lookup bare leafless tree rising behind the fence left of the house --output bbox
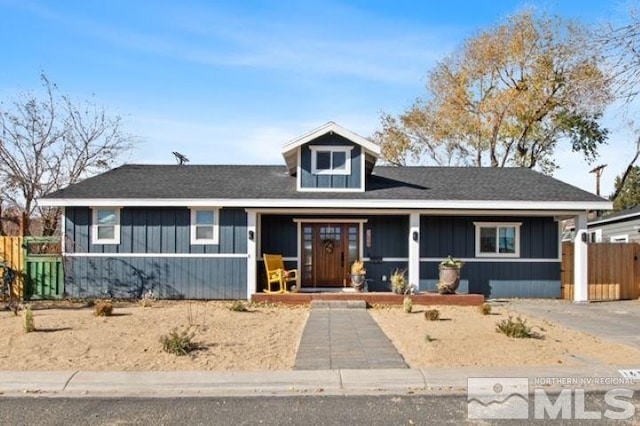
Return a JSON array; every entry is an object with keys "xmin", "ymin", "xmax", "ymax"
[{"xmin": 0, "ymin": 74, "xmax": 134, "ymax": 235}]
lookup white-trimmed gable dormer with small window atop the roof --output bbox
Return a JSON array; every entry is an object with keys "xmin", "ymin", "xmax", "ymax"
[{"xmin": 282, "ymin": 121, "xmax": 380, "ymax": 192}]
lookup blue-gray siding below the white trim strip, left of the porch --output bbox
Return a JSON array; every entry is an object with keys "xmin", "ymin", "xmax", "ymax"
[{"xmin": 65, "ymin": 257, "xmax": 247, "ymax": 299}]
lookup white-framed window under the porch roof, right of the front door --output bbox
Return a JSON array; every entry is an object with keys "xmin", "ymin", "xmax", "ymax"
[{"xmin": 474, "ymin": 222, "xmax": 522, "ymax": 257}]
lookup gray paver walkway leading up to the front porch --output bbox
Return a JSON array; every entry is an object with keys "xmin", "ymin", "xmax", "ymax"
[{"xmin": 293, "ymin": 301, "xmax": 408, "ymax": 370}]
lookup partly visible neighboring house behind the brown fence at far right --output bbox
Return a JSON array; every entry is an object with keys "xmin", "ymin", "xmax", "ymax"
[{"xmin": 587, "ymin": 206, "xmax": 640, "ymax": 243}]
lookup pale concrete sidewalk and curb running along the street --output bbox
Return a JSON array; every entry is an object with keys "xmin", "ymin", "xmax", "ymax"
[{"xmin": 0, "ymin": 362, "xmax": 640, "ymax": 397}]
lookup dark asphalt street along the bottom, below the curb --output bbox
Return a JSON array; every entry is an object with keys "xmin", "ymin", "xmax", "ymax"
[{"xmin": 0, "ymin": 392, "xmax": 640, "ymax": 426}]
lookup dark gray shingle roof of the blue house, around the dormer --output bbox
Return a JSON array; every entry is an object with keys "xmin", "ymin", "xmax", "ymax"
[{"xmin": 44, "ymin": 165, "xmax": 605, "ymax": 203}]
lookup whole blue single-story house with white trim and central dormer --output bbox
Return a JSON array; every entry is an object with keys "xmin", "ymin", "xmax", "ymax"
[{"xmin": 39, "ymin": 122, "xmax": 611, "ymax": 299}]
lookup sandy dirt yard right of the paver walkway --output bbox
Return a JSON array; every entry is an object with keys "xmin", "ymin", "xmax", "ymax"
[{"xmin": 371, "ymin": 306, "xmax": 640, "ymax": 367}]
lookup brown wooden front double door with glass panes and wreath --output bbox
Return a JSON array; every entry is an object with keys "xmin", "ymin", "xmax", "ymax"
[{"xmin": 301, "ymin": 223, "xmax": 360, "ymax": 287}]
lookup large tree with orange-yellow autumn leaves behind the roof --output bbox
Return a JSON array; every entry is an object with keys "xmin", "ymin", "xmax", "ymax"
[{"xmin": 374, "ymin": 12, "xmax": 612, "ymax": 173}]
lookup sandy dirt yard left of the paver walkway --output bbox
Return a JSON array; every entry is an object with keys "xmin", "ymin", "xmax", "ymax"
[{"xmin": 0, "ymin": 301, "xmax": 308, "ymax": 371}]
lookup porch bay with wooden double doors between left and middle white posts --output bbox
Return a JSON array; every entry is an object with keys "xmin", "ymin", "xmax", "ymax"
[{"xmin": 249, "ymin": 209, "xmax": 420, "ymax": 301}]
